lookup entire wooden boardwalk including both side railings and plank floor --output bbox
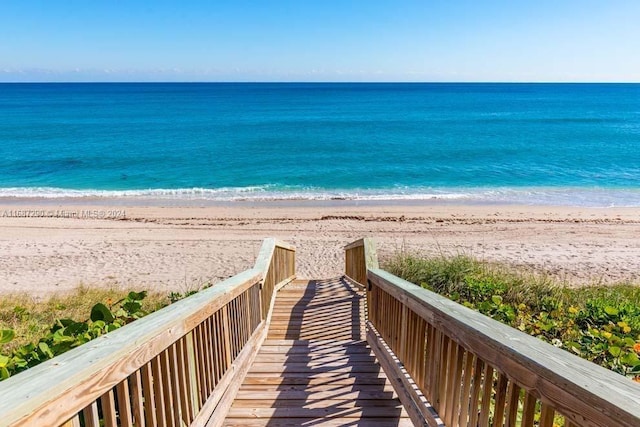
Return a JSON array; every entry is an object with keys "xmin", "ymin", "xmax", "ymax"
[{"xmin": 0, "ymin": 238, "xmax": 640, "ymax": 427}]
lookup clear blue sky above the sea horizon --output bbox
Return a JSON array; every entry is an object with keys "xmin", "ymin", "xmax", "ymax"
[{"xmin": 0, "ymin": 0, "xmax": 640, "ymax": 82}]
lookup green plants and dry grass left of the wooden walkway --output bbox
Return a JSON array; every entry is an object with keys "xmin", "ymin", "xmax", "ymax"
[{"xmin": 0, "ymin": 287, "xmax": 195, "ymax": 381}]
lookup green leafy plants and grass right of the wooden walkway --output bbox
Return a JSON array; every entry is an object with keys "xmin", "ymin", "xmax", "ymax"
[{"xmin": 384, "ymin": 254, "xmax": 640, "ymax": 382}]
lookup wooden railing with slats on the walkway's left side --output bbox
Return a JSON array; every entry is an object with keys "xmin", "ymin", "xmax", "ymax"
[{"xmin": 0, "ymin": 239, "xmax": 295, "ymax": 427}]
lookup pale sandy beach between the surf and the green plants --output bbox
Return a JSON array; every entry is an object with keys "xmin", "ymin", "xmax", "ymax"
[{"xmin": 0, "ymin": 200, "xmax": 640, "ymax": 296}]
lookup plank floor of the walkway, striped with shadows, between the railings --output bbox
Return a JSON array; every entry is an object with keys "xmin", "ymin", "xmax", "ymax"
[{"xmin": 225, "ymin": 279, "xmax": 413, "ymax": 426}]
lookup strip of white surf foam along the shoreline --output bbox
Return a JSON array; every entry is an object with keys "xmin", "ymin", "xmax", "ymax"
[{"xmin": 0, "ymin": 185, "xmax": 640, "ymax": 207}]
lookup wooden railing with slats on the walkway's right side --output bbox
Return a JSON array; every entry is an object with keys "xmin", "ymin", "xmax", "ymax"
[{"xmin": 346, "ymin": 237, "xmax": 640, "ymax": 427}]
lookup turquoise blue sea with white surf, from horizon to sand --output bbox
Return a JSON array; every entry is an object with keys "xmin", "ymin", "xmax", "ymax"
[{"xmin": 0, "ymin": 83, "xmax": 640, "ymax": 206}]
